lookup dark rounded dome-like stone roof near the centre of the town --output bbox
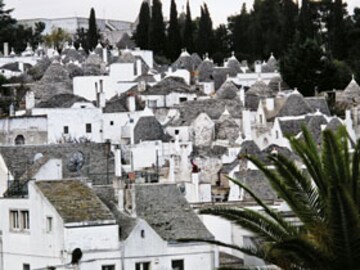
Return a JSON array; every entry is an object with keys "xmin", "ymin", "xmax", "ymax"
[{"xmin": 134, "ymin": 116, "xmax": 170, "ymax": 143}]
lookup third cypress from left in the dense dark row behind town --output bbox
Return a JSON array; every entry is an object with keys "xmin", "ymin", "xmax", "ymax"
[{"xmin": 166, "ymin": 0, "xmax": 181, "ymax": 61}]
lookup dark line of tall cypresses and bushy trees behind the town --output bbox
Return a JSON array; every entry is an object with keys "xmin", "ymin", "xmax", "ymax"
[{"xmin": 133, "ymin": 0, "xmax": 360, "ymax": 95}]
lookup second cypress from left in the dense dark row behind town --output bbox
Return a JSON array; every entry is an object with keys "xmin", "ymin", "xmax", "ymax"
[{"xmin": 149, "ymin": 0, "xmax": 166, "ymax": 55}]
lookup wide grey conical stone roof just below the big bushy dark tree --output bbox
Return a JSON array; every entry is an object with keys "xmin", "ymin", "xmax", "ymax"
[{"xmin": 277, "ymin": 92, "xmax": 314, "ymax": 117}]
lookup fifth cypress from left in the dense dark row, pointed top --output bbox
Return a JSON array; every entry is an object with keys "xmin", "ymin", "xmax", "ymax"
[{"xmin": 196, "ymin": 3, "xmax": 214, "ymax": 55}]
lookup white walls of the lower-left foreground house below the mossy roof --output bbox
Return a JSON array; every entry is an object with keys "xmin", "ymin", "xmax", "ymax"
[{"xmin": 0, "ymin": 182, "xmax": 120, "ymax": 270}]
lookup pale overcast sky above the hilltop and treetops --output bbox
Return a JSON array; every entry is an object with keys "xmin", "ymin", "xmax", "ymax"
[{"xmin": 4, "ymin": 0, "xmax": 360, "ymax": 25}]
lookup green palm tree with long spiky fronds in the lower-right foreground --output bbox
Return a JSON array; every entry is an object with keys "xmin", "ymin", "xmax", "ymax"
[{"xmin": 201, "ymin": 128, "xmax": 360, "ymax": 270}]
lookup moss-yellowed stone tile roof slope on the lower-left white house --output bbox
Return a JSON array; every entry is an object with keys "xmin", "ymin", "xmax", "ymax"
[{"xmin": 35, "ymin": 180, "xmax": 114, "ymax": 225}]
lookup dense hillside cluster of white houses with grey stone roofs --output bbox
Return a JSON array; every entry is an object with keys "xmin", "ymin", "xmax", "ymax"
[{"xmin": 0, "ymin": 39, "xmax": 360, "ymax": 270}]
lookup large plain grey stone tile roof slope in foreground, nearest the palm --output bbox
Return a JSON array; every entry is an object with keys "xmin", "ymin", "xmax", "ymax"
[{"xmin": 134, "ymin": 184, "xmax": 213, "ymax": 241}]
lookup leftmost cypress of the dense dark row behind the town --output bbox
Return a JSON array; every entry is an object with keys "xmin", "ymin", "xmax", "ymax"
[{"xmin": 134, "ymin": 1, "xmax": 150, "ymax": 50}]
